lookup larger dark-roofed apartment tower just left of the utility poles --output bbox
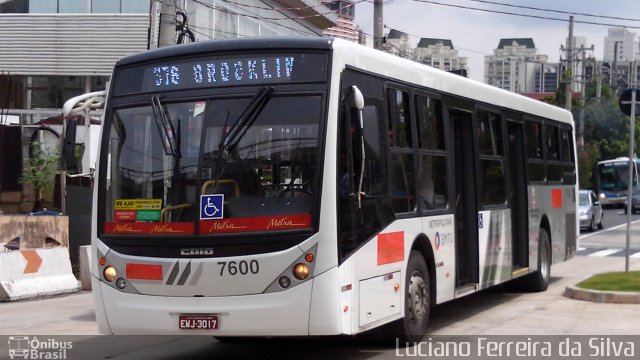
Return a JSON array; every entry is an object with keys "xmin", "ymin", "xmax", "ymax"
[{"xmin": 484, "ymin": 38, "xmax": 551, "ymax": 93}]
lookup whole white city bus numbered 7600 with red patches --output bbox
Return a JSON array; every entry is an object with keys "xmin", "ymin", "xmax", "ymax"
[{"xmin": 92, "ymin": 38, "xmax": 578, "ymax": 341}]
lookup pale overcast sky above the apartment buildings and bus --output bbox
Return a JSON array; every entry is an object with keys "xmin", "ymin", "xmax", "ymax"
[{"xmin": 355, "ymin": 0, "xmax": 640, "ymax": 81}]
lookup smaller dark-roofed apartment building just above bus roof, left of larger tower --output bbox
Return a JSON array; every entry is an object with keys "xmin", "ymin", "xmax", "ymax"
[{"xmin": 413, "ymin": 38, "xmax": 469, "ymax": 75}]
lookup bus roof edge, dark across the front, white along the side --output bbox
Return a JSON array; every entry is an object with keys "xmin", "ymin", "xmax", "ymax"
[{"xmin": 116, "ymin": 37, "xmax": 573, "ymax": 126}]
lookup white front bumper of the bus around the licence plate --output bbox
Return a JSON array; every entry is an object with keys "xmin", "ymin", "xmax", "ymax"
[{"xmin": 94, "ymin": 278, "xmax": 313, "ymax": 336}]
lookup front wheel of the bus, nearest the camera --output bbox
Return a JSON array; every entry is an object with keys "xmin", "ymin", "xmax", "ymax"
[{"xmin": 385, "ymin": 250, "xmax": 432, "ymax": 345}]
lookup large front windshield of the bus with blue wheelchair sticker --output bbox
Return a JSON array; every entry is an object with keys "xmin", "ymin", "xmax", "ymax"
[{"xmin": 102, "ymin": 91, "xmax": 323, "ymax": 235}]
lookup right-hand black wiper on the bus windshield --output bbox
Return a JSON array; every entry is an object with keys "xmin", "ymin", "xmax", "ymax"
[{"xmin": 218, "ymin": 86, "xmax": 273, "ymax": 153}]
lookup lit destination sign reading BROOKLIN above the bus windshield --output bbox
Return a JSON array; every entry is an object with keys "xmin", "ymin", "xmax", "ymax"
[{"xmin": 116, "ymin": 53, "xmax": 327, "ymax": 95}]
